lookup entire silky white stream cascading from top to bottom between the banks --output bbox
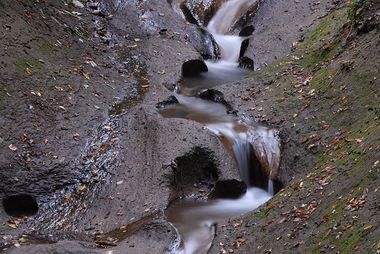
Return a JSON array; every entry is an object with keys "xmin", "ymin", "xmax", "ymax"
[{"xmin": 160, "ymin": 0, "xmax": 280, "ymax": 254}]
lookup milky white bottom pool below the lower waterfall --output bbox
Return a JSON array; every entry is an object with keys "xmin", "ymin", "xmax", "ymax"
[{"xmin": 167, "ymin": 188, "xmax": 272, "ymax": 254}]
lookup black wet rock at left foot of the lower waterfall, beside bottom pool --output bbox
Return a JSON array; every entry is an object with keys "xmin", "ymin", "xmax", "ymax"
[{"xmin": 209, "ymin": 179, "xmax": 247, "ymax": 199}]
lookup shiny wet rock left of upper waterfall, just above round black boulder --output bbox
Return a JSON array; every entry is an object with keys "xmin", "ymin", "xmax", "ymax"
[{"xmin": 187, "ymin": 25, "xmax": 220, "ymax": 59}]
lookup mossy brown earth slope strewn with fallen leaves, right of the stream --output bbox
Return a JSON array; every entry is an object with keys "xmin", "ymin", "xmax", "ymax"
[{"xmin": 211, "ymin": 1, "xmax": 380, "ymax": 253}]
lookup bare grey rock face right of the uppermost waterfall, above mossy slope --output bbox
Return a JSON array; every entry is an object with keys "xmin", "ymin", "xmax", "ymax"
[{"xmin": 245, "ymin": 0, "xmax": 333, "ymax": 67}]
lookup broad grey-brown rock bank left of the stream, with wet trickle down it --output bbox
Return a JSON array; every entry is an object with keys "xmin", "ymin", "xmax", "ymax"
[{"xmin": 0, "ymin": 1, "xmax": 239, "ymax": 253}]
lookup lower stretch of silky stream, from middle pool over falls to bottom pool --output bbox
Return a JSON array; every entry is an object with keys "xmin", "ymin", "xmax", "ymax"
[{"xmin": 161, "ymin": 94, "xmax": 280, "ymax": 254}]
